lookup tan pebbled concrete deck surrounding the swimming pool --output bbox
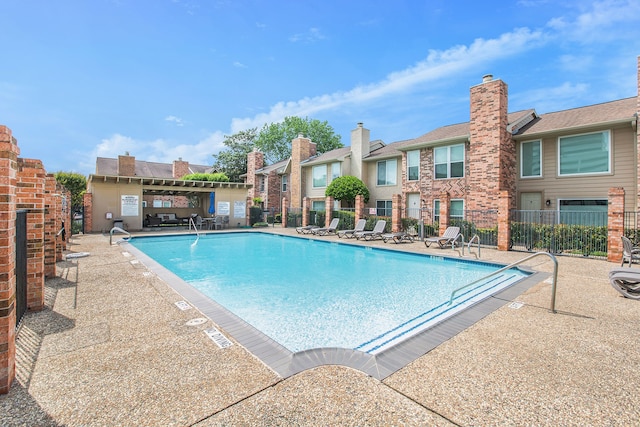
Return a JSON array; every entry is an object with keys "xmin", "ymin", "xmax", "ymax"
[{"xmin": 0, "ymin": 228, "xmax": 640, "ymax": 426}]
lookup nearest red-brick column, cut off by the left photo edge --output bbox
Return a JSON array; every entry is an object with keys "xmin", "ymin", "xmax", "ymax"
[{"xmin": 0, "ymin": 126, "xmax": 20, "ymax": 394}]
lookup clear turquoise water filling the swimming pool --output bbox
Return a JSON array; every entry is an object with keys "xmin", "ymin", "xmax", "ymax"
[{"xmin": 130, "ymin": 233, "xmax": 527, "ymax": 354}]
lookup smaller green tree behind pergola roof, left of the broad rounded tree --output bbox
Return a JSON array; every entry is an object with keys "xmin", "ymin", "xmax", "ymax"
[{"xmin": 213, "ymin": 128, "xmax": 257, "ymax": 182}]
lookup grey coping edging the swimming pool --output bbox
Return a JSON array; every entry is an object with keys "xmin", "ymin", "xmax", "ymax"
[{"xmin": 120, "ymin": 241, "xmax": 550, "ymax": 380}]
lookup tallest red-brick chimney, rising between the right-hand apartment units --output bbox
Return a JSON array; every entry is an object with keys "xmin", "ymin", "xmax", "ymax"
[{"xmin": 465, "ymin": 74, "xmax": 516, "ymax": 210}]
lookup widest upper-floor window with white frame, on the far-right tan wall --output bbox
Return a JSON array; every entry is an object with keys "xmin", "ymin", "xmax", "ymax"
[{"xmin": 558, "ymin": 131, "xmax": 611, "ymax": 176}]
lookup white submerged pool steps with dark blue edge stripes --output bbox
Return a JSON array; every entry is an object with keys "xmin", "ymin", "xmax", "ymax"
[{"xmin": 354, "ymin": 271, "xmax": 522, "ymax": 354}]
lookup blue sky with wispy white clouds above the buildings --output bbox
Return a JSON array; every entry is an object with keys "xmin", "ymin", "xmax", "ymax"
[{"xmin": 0, "ymin": 0, "xmax": 640, "ymax": 175}]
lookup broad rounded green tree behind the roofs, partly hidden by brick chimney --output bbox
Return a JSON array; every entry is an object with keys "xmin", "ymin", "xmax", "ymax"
[{"xmin": 255, "ymin": 116, "xmax": 344, "ymax": 164}]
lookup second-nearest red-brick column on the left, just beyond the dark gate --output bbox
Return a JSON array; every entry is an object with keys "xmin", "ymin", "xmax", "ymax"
[{"xmin": 16, "ymin": 159, "xmax": 46, "ymax": 310}]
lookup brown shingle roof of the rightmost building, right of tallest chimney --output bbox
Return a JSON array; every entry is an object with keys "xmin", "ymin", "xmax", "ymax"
[{"xmin": 517, "ymin": 97, "xmax": 638, "ymax": 135}]
